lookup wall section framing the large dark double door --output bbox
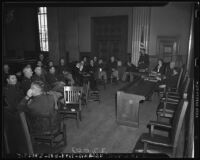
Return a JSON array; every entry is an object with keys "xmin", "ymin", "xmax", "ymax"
[{"xmin": 79, "ymin": 7, "xmax": 132, "ymax": 53}]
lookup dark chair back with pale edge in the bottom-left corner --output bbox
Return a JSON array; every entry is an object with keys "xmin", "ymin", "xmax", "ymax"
[{"xmin": 4, "ymin": 109, "xmax": 33, "ymax": 154}]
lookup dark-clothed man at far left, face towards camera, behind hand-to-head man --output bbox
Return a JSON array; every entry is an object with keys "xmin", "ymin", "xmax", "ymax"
[{"xmin": 4, "ymin": 73, "xmax": 24, "ymax": 112}]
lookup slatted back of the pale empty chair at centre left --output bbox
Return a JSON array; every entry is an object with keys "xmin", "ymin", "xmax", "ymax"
[{"xmin": 64, "ymin": 86, "xmax": 83, "ymax": 104}]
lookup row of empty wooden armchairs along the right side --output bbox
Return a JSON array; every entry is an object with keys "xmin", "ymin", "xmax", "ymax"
[{"xmin": 133, "ymin": 66, "xmax": 192, "ymax": 157}]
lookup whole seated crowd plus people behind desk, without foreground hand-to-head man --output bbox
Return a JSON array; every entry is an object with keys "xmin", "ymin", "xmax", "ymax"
[{"xmin": 3, "ymin": 50, "xmax": 178, "ymax": 115}]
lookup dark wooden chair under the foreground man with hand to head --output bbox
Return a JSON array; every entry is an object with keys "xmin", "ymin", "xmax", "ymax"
[{"xmin": 26, "ymin": 111, "xmax": 67, "ymax": 151}]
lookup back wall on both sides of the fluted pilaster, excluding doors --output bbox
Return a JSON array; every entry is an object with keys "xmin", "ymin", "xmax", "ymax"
[{"xmin": 48, "ymin": 2, "xmax": 191, "ymax": 62}]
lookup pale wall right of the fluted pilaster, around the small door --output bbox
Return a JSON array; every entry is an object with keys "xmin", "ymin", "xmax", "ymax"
[{"xmin": 149, "ymin": 2, "xmax": 191, "ymax": 63}]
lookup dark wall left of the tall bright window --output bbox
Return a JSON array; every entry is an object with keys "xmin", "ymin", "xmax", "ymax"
[{"xmin": 4, "ymin": 7, "xmax": 39, "ymax": 58}]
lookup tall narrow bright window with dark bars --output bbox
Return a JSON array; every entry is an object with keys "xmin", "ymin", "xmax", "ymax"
[{"xmin": 38, "ymin": 7, "xmax": 49, "ymax": 51}]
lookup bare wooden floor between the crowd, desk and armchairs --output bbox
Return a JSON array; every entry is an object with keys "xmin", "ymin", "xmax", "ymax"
[{"xmin": 34, "ymin": 82, "xmax": 166, "ymax": 153}]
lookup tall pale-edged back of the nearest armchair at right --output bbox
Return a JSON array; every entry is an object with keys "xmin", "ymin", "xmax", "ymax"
[{"xmin": 171, "ymin": 99, "xmax": 188, "ymax": 151}]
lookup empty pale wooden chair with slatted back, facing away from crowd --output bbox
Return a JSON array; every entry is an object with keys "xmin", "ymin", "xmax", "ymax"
[{"xmin": 59, "ymin": 86, "xmax": 83, "ymax": 127}]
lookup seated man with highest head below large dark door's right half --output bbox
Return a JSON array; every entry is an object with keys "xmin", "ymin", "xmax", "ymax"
[{"xmin": 108, "ymin": 56, "xmax": 119, "ymax": 81}]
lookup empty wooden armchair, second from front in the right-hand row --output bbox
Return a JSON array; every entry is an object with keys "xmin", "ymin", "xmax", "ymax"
[{"xmin": 156, "ymin": 78, "xmax": 190, "ymax": 121}]
